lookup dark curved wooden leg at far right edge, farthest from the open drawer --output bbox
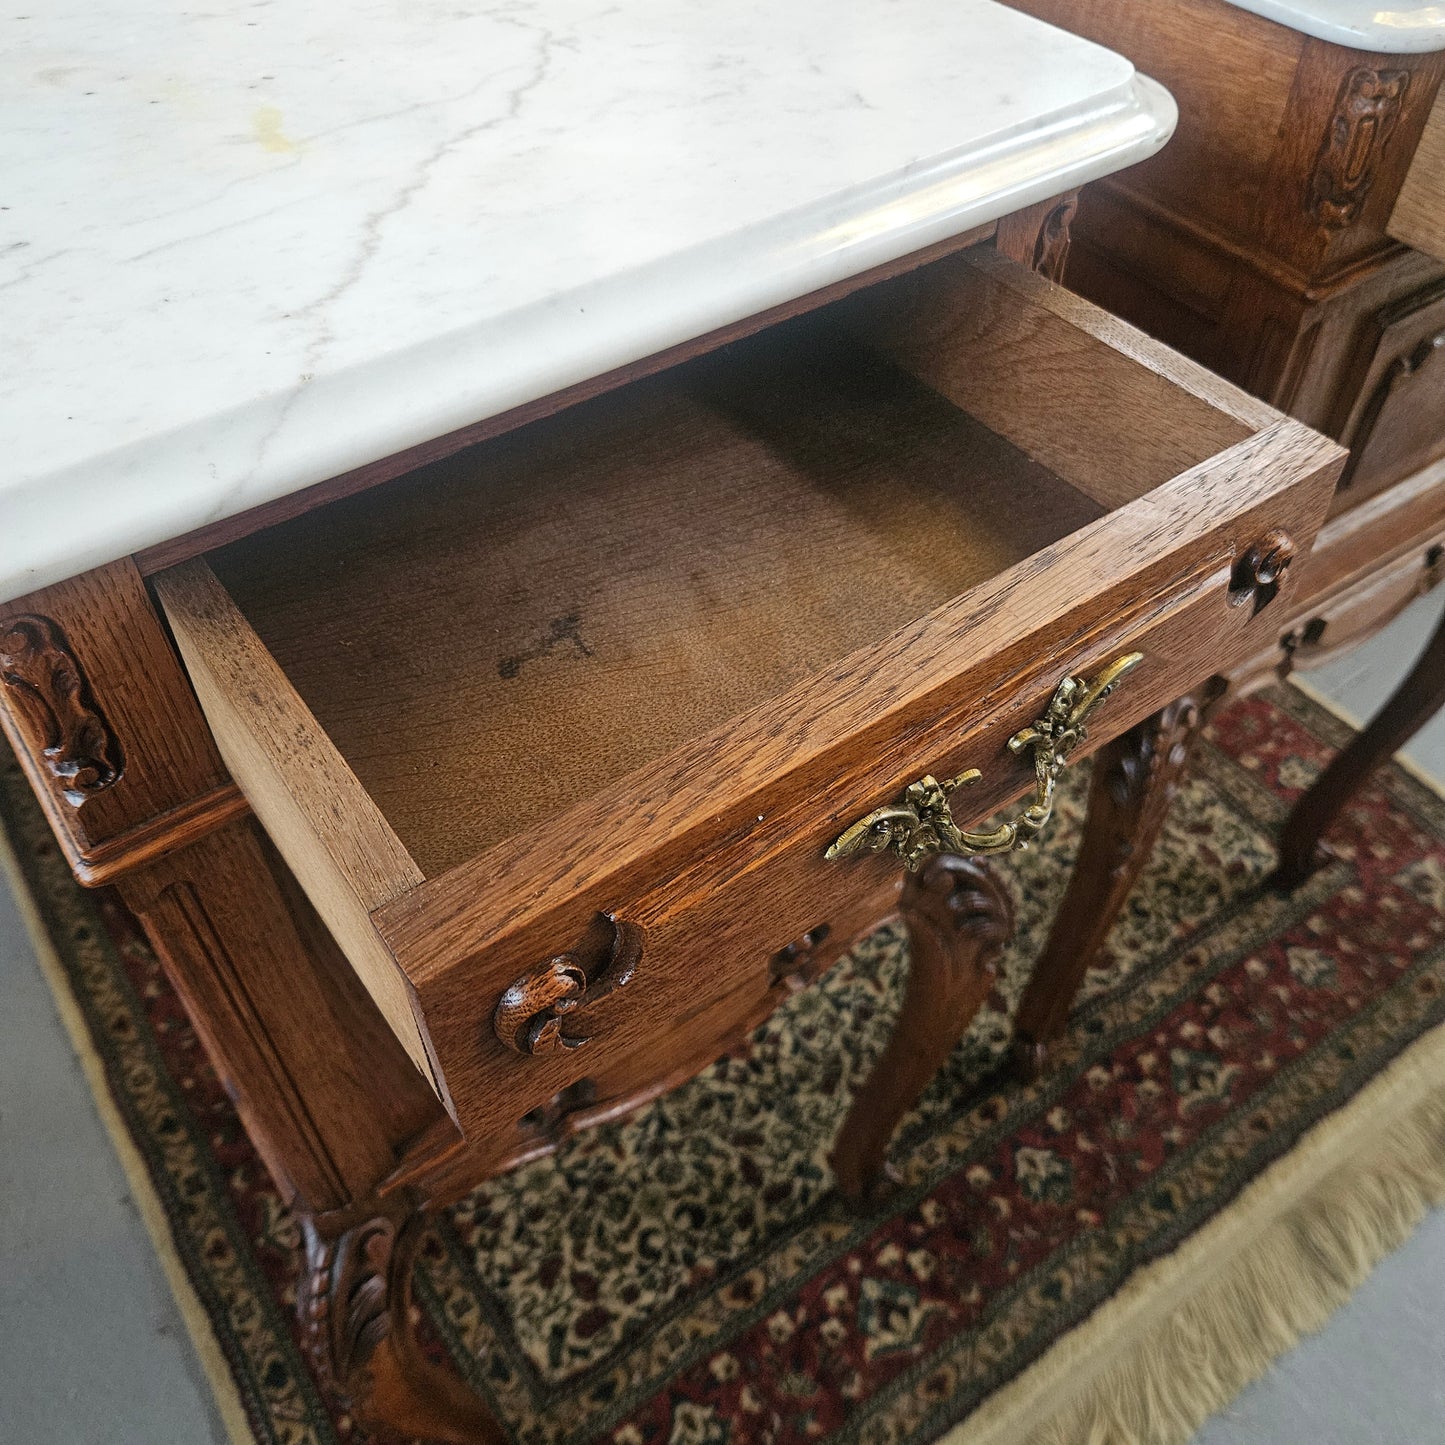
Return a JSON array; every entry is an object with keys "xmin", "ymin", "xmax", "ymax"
[{"xmin": 1270, "ymin": 601, "xmax": 1445, "ymax": 893}]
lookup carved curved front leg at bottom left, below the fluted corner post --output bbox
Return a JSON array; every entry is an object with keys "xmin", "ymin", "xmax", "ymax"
[{"xmin": 296, "ymin": 1201, "xmax": 506, "ymax": 1445}]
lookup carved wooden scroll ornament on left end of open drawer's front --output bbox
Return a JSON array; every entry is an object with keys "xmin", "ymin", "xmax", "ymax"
[{"xmin": 491, "ymin": 913, "xmax": 643, "ymax": 1055}]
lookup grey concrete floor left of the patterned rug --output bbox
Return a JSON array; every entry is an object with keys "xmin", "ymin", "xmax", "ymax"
[{"xmin": 0, "ymin": 849, "xmax": 225, "ymax": 1445}]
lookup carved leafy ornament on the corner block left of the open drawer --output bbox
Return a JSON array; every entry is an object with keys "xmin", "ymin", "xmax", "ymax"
[{"xmin": 0, "ymin": 613, "xmax": 126, "ymax": 806}]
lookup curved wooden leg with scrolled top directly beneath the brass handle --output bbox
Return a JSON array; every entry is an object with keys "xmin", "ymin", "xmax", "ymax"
[{"xmin": 831, "ymin": 854, "xmax": 1013, "ymax": 1202}]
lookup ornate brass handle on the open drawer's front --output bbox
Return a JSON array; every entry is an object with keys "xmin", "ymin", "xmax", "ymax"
[{"xmin": 824, "ymin": 652, "xmax": 1143, "ymax": 873}]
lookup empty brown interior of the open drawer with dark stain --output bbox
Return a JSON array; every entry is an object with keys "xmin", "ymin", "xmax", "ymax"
[{"xmin": 200, "ymin": 249, "xmax": 1251, "ymax": 877}]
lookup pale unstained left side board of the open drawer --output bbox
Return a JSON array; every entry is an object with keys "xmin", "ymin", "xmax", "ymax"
[{"xmin": 156, "ymin": 559, "xmax": 441, "ymax": 1092}]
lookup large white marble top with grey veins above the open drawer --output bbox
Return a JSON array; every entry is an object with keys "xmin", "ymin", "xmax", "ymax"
[{"xmin": 0, "ymin": 0, "xmax": 1175, "ymax": 598}]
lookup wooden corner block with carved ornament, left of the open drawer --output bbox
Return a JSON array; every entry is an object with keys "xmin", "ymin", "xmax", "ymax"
[{"xmin": 0, "ymin": 561, "xmax": 246, "ymax": 884}]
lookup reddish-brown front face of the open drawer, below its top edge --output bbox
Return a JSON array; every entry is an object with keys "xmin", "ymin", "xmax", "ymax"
[{"xmin": 378, "ymin": 497, "xmax": 1321, "ymax": 1147}]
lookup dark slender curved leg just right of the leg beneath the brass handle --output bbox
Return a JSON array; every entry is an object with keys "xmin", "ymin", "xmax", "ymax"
[{"xmin": 1012, "ymin": 696, "xmax": 1205, "ymax": 1081}]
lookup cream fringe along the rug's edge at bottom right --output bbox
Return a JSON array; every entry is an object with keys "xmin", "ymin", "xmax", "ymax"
[{"xmin": 945, "ymin": 1027, "xmax": 1445, "ymax": 1445}]
